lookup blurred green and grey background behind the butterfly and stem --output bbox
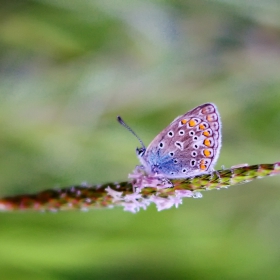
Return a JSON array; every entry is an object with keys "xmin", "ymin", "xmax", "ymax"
[{"xmin": 0, "ymin": 0, "xmax": 280, "ymax": 280}]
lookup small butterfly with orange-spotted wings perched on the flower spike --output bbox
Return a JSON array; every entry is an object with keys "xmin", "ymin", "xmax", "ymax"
[{"xmin": 117, "ymin": 103, "xmax": 222, "ymax": 179}]
